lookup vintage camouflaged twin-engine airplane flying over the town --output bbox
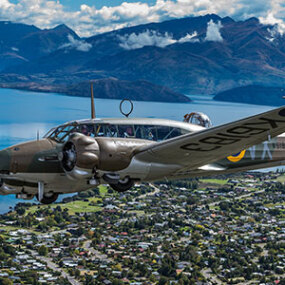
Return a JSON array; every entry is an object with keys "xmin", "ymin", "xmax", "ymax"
[{"xmin": 0, "ymin": 89, "xmax": 285, "ymax": 204}]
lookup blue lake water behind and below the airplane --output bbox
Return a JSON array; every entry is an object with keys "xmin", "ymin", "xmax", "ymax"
[{"xmin": 0, "ymin": 89, "xmax": 274, "ymax": 214}]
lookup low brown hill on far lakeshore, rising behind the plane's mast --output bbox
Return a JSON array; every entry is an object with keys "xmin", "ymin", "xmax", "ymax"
[{"xmin": 0, "ymin": 78, "xmax": 191, "ymax": 103}]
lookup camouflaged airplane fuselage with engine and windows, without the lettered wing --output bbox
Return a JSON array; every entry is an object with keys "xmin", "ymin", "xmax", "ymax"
[{"xmin": 0, "ymin": 116, "xmax": 285, "ymax": 201}]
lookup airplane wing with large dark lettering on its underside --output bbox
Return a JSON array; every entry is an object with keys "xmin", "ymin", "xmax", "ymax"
[{"xmin": 135, "ymin": 106, "xmax": 285, "ymax": 171}]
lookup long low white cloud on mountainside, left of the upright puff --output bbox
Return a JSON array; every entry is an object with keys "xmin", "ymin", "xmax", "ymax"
[{"xmin": 118, "ymin": 30, "xmax": 199, "ymax": 50}]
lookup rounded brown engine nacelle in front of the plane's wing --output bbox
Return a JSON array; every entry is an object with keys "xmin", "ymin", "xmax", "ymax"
[{"xmin": 59, "ymin": 133, "xmax": 133, "ymax": 179}]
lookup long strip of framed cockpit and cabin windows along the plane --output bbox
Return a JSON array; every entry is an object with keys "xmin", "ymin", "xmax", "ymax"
[{"xmin": 45, "ymin": 121, "xmax": 189, "ymax": 143}]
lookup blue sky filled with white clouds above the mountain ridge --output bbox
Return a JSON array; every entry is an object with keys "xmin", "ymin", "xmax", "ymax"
[{"xmin": 0, "ymin": 0, "xmax": 285, "ymax": 37}]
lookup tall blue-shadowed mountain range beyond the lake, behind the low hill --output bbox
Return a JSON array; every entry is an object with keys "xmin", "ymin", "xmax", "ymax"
[{"xmin": 0, "ymin": 14, "xmax": 285, "ymax": 101}]
